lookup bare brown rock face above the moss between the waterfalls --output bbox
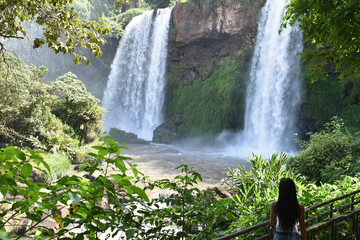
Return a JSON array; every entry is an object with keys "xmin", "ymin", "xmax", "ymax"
[{"xmin": 167, "ymin": 0, "xmax": 265, "ymax": 83}]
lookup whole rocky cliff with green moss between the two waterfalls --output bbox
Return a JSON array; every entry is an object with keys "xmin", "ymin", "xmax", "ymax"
[{"xmin": 154, "ymin": 0, "xmax": 266, "ymax": 142}]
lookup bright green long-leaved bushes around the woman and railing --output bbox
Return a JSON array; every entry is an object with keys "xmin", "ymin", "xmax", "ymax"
[{"xmin": 222, "ymin": 154, "xmax": 360, "ymax": 240}]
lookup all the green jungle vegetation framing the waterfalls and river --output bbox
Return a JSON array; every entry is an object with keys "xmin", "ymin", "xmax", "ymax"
[{"xmin": 0, "ymin": 0, "xmax": 360, "ymax": 240}]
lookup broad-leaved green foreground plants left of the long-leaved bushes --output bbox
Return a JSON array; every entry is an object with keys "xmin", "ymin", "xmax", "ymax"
[{"xmin": 0, "ymin": 139, "xmax": 236, "ymax": 239}]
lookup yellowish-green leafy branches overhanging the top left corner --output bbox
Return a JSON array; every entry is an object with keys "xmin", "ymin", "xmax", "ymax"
[{"xmin": 0, "ymin": 0, "xmax": 127, "ymax": 64}]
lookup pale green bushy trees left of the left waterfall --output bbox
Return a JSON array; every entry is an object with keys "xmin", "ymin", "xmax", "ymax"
[{"xmin": 0, "ymin": 54, "xmax": 104, "ymax": 158}]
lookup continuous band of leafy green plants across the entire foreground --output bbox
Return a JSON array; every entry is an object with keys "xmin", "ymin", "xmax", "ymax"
[{"xmin": 0, "ymin": 139, "xmax": 360, "ymax": 240}]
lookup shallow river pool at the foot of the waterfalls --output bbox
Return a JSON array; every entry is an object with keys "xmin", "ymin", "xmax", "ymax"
[{"xmin": 121, "ymin": 143, "xmax": 250, "ymax": 198}]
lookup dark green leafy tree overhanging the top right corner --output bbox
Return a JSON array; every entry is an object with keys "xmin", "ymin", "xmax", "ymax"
[{"xmin": 282, "ymin": 0, "xmax": 360, "ymax": 79}]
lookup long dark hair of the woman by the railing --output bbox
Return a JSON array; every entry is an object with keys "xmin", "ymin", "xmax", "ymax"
[{"xmin": 276, "ymin": 178, "xmax": 300, "ymax": 232}]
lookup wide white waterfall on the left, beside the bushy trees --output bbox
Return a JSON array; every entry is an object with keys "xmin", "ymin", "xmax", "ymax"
[{"xmin": 103, "ymin": 8, "xmax": 172, "ymax": 140}]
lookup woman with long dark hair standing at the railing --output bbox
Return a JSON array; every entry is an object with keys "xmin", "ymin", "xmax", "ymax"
[{"xmin": 270, "ymin": 178, "xmax": 307, "ymax": 240}]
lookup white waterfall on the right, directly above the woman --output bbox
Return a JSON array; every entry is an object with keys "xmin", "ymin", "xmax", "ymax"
[{"xmin": 226, "ymin": 0, "xmax": 303, "ymax": 157}]
